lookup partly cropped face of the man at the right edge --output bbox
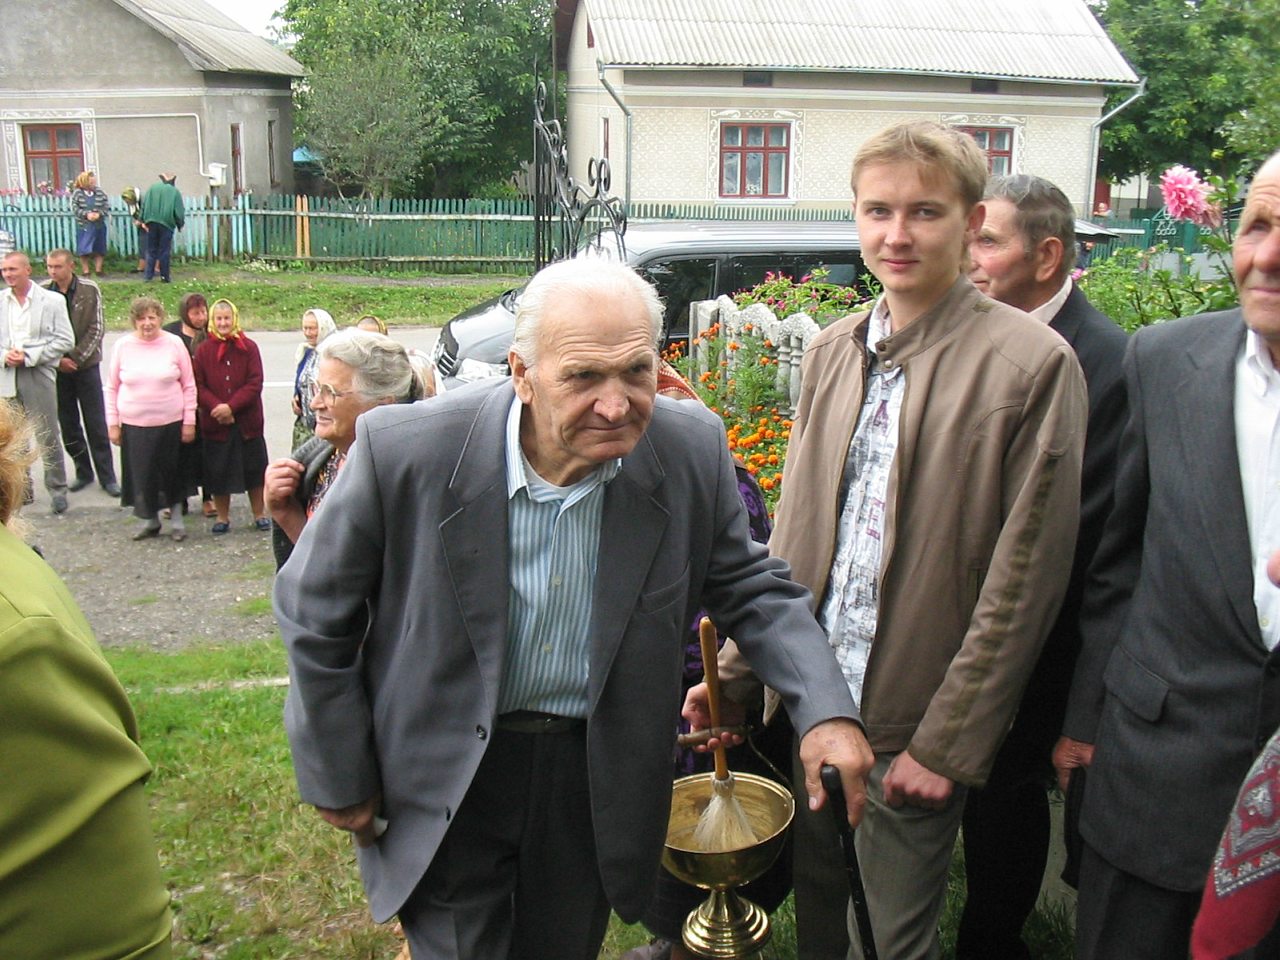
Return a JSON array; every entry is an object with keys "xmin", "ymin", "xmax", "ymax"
[{"xmin": 1233, "ymin": 157, "xmax": 1280, "ymax": 355}]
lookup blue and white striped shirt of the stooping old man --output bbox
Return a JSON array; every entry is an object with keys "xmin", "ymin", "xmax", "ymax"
[{"xmin": 498, "ymin": 398, "xmax": 622, "ymax": 717}]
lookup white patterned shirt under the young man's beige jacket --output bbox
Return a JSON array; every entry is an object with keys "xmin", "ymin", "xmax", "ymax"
[{"xmin": 818, "ymin": 298, "xmax": 906, "ymax": 705}]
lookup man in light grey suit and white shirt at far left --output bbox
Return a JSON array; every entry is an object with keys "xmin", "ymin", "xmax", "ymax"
[{"xmin": 0, "ymin": 251, "xmax": 74, "ymax": 513}]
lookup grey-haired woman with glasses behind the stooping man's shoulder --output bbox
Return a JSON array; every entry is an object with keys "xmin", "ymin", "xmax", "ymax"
[{"xmin": 265, "ymin": 329, "xmax": 422, "ymax": 567}]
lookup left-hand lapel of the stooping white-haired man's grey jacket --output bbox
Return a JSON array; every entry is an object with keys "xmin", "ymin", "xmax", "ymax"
[{"xmin": 440, "ymin": 385, "xmax": 515, "ymax": 705}]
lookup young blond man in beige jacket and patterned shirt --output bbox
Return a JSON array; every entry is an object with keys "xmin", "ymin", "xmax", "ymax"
[{"xmin": 689, "ymin": 122, "xmax": 1087, "ymax": 960}]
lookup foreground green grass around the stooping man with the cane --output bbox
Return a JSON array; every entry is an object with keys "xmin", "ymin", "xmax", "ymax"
[{"xmin": 106, "ymin": 640, "xmax": 1071, "ymax": 960}]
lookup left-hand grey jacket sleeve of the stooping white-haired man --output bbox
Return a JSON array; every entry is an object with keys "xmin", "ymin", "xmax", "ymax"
[{"xmin": 274, "ymin": 419, "xmax": 385, "ymax": 808}]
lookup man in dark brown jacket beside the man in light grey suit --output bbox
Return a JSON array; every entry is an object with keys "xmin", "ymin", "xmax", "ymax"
[{"xmin": 45, "ymin": 250, "xmax": 120, "ymax": 497}]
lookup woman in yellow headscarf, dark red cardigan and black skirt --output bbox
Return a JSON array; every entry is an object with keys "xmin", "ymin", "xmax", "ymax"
[{"xmin": 192, "ymin": 300, "xmax": 271, "ymax": 536}]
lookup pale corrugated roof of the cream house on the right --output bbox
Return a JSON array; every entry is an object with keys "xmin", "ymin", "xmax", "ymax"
[{"xmin": 582, "ymin": 0, "xmax": 1138, "ymax": 83}]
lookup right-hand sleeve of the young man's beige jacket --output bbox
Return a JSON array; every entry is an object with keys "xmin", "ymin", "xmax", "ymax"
[{"xmin": 908, "ymin": 343, "xmax": 1088, "ymax": 785}]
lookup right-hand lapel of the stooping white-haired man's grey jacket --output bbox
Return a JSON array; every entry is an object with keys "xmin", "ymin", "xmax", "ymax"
[{"xmin": 588, "ymin": 435, "xmax": 669, "ymax": 713}]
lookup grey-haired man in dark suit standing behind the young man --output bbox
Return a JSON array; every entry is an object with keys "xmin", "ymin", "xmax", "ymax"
[{"xmin": 956, "ymin": 174, "xmax": 1126, "ymax": 960}]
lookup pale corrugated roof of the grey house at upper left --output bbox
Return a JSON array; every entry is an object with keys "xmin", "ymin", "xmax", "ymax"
[{"xmin": 115, "ymin": 0, "xmax": 306, "ymax": 77}]
